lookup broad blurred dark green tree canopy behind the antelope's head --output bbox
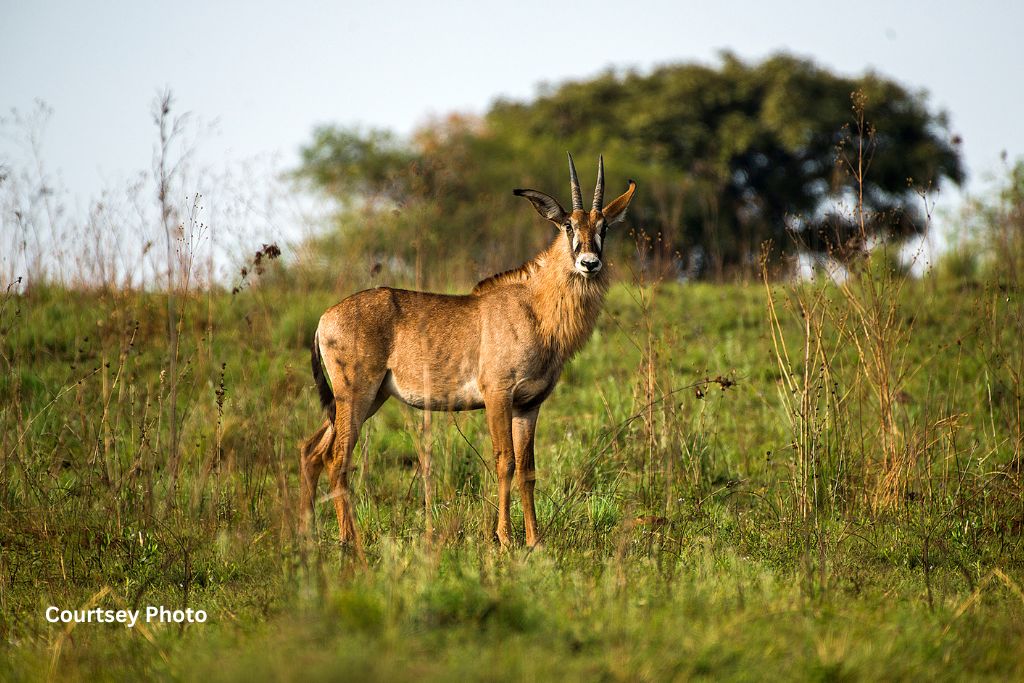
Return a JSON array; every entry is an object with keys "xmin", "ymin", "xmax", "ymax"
[{"xmin": 298, "ymin": 53, "xmax": 964, "ymax": 284}]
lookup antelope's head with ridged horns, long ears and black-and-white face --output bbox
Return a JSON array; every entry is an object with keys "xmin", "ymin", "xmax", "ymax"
[{"xmin": 512, "ymin": 154, "xmax": 637, "ymax": 279}]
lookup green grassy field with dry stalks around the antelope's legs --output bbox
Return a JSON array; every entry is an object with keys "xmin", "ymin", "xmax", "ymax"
[{"xmin": 0, "ymin": 274, "xmax": 1024, "ymax": 680}]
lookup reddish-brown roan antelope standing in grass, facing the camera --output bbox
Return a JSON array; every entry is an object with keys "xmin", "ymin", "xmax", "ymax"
[{"xmin": 300, "ymin": 155, "xmax": 636, "ymax": 546}]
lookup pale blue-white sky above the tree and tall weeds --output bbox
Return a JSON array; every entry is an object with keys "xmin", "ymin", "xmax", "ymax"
[{"xmin": 0, "ymin": 0, "xmax": 1024, "ymax": 232}]
